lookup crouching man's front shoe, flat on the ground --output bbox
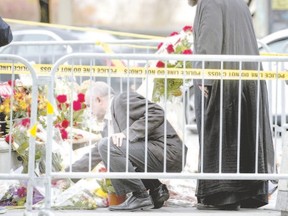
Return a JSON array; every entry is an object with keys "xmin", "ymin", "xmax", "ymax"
[{"xmin": 109, "ymin": 195, "xmax": 154, "ymax": 211}]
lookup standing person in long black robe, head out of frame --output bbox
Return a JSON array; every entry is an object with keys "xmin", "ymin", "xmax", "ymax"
[{"xmin": 188, "ymin": 0, "xmax": 274, "ymax": 210}]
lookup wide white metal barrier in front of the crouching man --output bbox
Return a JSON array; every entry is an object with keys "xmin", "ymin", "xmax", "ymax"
[{"xmin": 22, "ymin": 53, "xmax": 288, "ymax": 214}]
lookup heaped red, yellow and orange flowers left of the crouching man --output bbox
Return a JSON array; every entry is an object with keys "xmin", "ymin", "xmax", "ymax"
[{"xmin": 0, "ymin": 80, "xmax": 86, "ymax": 175}]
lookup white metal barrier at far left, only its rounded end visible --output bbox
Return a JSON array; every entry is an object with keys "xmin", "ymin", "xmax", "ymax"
[{"xmin": 0, "ymin": 54, "xmax": 38, "ymax": 214}]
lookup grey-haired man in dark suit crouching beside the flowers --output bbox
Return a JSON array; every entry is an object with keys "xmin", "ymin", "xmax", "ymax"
[{"xmin": 72, "ymin": 82, "xmax": 187, "ymax": 211}]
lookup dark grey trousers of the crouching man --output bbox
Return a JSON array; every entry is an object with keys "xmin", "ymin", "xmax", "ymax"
[{"xmin": 98, "ymin": 138, "xmax": 163, "ymax": 194}]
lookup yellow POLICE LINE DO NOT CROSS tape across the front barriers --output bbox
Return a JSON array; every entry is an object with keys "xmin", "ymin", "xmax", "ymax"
[{"xmin": 0, "ymin": 63, "xmax": 288, "ymax": 80}]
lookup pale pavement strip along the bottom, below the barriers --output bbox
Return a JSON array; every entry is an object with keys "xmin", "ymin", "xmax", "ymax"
[{"xmin": 3, "ymin": 207, "xmax": 281, "ymax": 216}]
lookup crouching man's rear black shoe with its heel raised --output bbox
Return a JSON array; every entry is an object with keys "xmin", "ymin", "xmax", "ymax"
[{"xmin": 150, "ymin": 184, "xmax": 169, "ymax": 209}]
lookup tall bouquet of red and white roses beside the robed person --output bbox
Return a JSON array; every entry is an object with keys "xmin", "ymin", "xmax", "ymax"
[{"xmin": 152, "ymin": 26, "xmax": 193, "ymax": 102}]
